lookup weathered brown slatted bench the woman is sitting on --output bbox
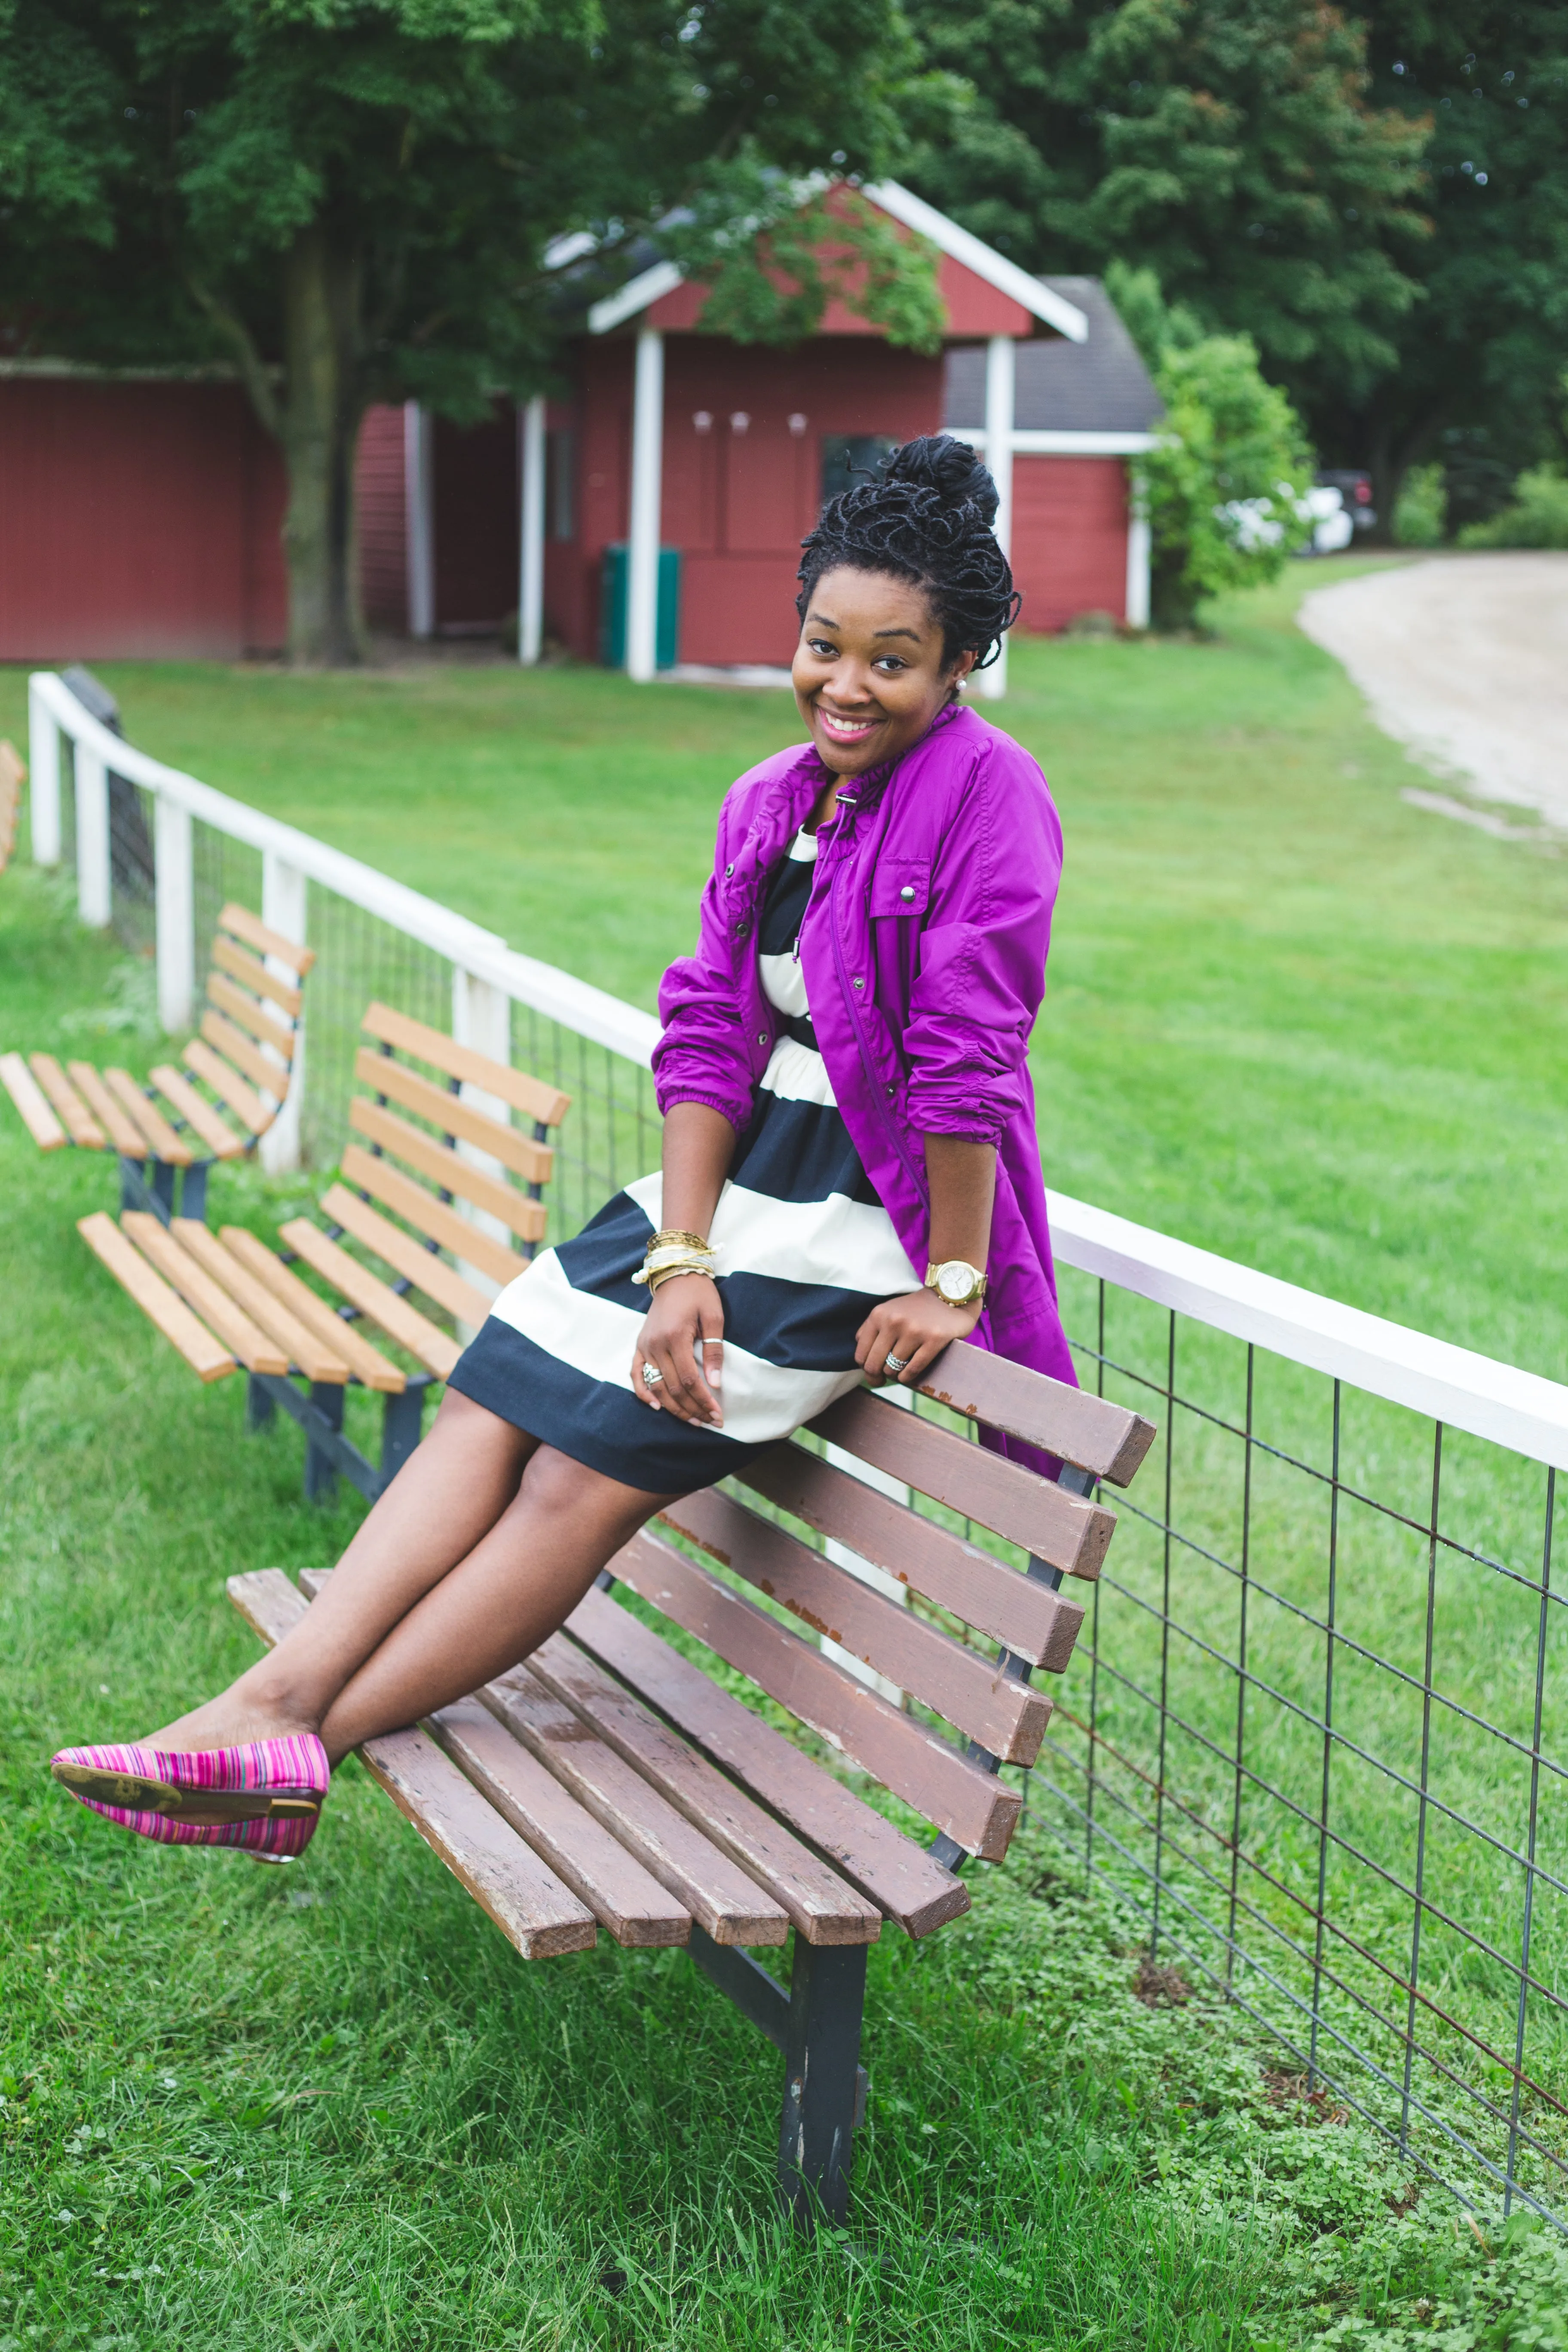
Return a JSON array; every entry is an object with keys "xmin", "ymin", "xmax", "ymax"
[{"xmin": 228, "ymin": 1345, "xmax": 1154, "ymax": 2225}]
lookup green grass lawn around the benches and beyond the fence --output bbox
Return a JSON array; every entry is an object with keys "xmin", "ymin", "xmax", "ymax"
[{"xmin": 0, "ymin": 567, "xmax": 1568, "ymax": 2352}]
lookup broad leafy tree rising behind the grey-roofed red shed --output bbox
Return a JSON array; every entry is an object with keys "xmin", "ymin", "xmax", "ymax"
[{"xmin": 912, "ymin": 0, "xmax": 1427, "ymax": 430}]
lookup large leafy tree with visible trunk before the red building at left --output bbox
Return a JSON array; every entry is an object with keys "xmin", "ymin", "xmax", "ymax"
[{"xmin": 0, "ymin": 0, "xmax": 931, "ymax": 661}]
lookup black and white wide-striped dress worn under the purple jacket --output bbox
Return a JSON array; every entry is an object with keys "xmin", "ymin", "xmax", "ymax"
[{"xmin": 449, "ymin": 830, "xmax": 919, "ymax": 1494}]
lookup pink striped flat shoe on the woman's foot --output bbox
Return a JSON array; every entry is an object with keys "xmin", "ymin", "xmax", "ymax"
[{"xmin": 49, "ymin": 1731, "xmax": 331, "ymax": 1863}]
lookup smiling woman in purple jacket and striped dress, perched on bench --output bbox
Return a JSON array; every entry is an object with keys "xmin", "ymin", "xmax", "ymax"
[{"xmin": 54, "ymin": 440, "xmax": 1072, "ymax": 1856}]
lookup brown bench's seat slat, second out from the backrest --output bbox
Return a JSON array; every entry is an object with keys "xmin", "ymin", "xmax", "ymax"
[{"xmin": 529, "ymin": 1635, "xmax": 882, "ymax": 1945}]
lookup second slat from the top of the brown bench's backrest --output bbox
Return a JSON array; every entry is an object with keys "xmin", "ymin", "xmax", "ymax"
[{"xmin": 811, "ymin": 1390, "xmax": 1117, "ymax": 1578}]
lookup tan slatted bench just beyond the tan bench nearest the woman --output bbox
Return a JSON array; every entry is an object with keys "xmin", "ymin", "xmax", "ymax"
[{"xmin": 0, "ymin": 906, "xmax": 315, "ymax": 1225}]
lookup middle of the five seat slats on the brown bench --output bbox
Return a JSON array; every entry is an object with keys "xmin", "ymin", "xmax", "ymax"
[{"xmin": 480, "ymin": 1665, "xmax": 790, "ymax": 1943}]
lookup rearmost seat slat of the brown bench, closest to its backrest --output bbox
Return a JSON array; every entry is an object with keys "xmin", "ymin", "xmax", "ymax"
[{"xmin": 567, "ymin": 1564, "xmax": 968, "ymax": 1936}]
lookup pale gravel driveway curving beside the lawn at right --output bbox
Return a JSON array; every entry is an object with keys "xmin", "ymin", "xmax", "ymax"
[{"xmin": 1300, "ymin": 555, "xmax": 1568, "ymax": 833}]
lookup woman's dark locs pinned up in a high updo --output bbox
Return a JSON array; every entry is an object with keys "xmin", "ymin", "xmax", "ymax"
[{"xmin": 795, "ymin": 433, "xmax": 1023, "ymax": 671}]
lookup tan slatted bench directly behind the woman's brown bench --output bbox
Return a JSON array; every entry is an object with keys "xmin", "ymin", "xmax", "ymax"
[{"xmin": 77, "ymin": 1004, "xmax": 571, "ymax": 1503}]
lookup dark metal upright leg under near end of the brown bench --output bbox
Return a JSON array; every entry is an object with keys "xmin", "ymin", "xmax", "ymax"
[{"xmin": 778, "ymin": 1936, "xmax": 867, "ymax": 2230}]
